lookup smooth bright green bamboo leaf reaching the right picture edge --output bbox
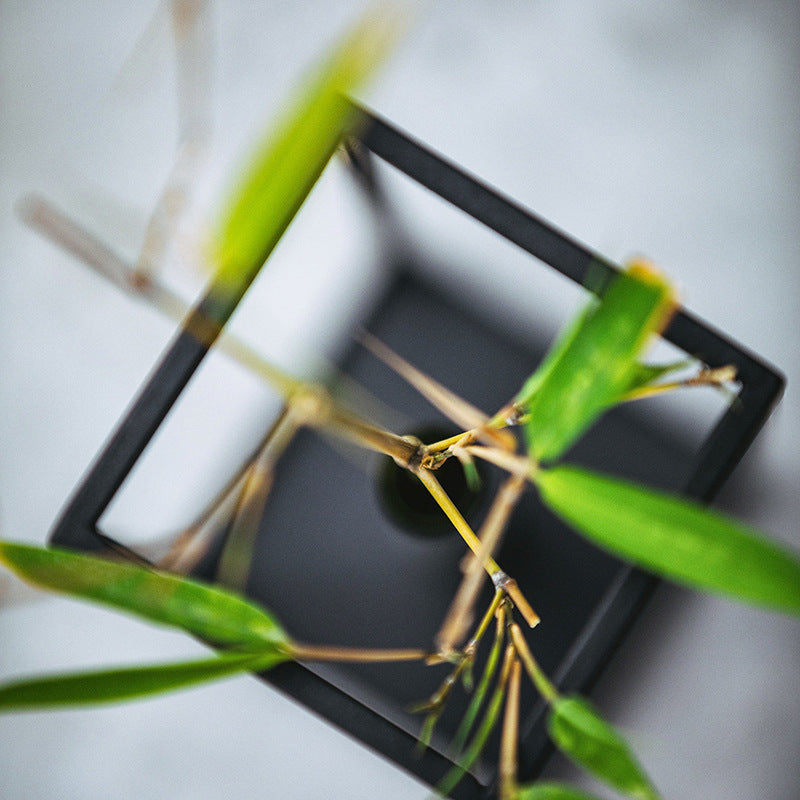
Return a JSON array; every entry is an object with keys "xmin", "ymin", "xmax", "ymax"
[{"xmin": 533, "ymin": 466, "xmax": 800, "ymax": 614}]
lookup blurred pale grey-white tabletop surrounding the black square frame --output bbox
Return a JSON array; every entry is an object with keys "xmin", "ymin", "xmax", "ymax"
[{"xmin": 0, "ymin": 0, "xmax": 800, "ymax": 800}]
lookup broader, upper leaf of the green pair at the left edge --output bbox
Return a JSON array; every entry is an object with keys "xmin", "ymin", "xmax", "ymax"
[{"xmin": 0, "ymin": 541, "xmax": 291, "ymax": 650}]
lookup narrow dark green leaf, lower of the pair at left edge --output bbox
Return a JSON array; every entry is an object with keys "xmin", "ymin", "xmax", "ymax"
[{"xmin": 0, "ymin": 649, "xmax": 289, "ymax": 712}]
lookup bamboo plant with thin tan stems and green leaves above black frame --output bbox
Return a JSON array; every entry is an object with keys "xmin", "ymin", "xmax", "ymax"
[{"xmin": 0, "ymin": 7, "xmax": 800, "ymax": 800}]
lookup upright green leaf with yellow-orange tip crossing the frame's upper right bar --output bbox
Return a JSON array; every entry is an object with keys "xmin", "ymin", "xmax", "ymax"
[{"xmin": 516, "ymin": 263, "xmax": 674, "ymax": 461}]
